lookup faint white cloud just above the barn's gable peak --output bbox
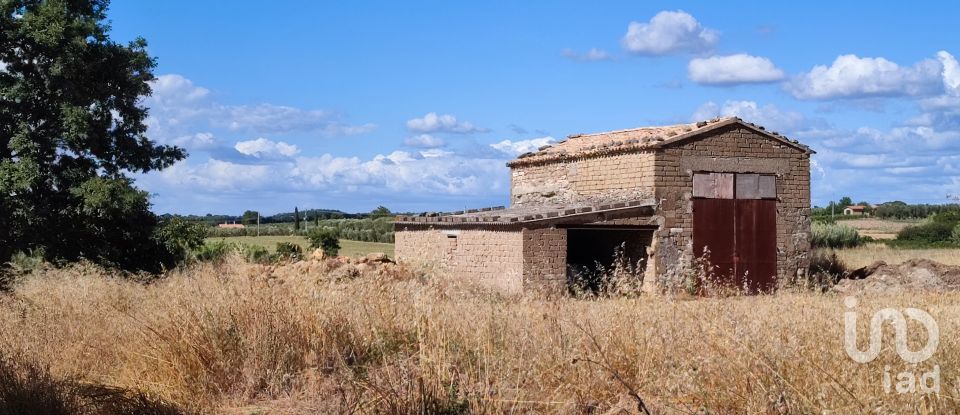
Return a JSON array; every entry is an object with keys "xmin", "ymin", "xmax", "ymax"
[{"xmin": 691, "ymin": 101, "xmax": 810, "ymax": 132}]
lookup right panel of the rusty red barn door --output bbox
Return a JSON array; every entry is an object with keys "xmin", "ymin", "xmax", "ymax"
[{"xmin": 734, "ymin": 199, "xmax": 777, "ymax": 293}]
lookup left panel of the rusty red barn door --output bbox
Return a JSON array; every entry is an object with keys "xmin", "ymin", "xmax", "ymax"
[{"xmin": 693, "ymin": 199, "xmax": 737, "ymax": 282}]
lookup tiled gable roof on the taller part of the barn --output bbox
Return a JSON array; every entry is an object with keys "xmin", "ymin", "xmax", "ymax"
[{"xmin": 507, "ymin": 117, "xmax": 813, "ymax": 167}]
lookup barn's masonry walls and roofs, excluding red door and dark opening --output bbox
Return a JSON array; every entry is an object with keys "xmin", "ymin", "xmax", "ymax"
[{"xmin": 396, "ymin": 118, "xmax": 812, "ymax": 293}]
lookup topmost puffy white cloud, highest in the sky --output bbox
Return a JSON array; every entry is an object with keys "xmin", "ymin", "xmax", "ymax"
[{"xmin": 623, "ymin": 10, "xmax": 719, "ymax": 55}]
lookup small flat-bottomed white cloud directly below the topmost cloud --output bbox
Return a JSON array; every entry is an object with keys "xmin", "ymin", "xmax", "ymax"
[{"xmin": 687, "ymin": 53, "xmax": 784, "ymax": 85}]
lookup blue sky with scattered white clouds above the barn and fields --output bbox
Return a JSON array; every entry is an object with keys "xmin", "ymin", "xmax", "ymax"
[{"xmin": 109, "ymin": 1, "xmax": 960, "ymax": 214}]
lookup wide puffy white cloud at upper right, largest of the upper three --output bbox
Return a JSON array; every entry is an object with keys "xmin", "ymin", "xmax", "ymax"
[{"xmin": 787, "ymin": 55, "xmax": 942, "ymax": 99}]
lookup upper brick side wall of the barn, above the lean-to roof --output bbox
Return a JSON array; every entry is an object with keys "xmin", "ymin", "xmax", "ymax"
[{"xmin": 510, "ymin": 152, "xmax": 654, "ymax": 205}]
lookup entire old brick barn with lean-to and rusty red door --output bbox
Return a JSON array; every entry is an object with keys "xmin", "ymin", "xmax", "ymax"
[{"xmin": 394, "ymin": 118, "xmax": 813, "ymax": 293}]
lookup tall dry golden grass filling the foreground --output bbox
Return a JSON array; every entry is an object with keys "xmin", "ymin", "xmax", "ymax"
[{"xmin": 0, "ymin": 260, "xmax": 960, "ymax": 414}]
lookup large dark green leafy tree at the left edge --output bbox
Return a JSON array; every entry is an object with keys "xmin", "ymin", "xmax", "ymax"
[{"xmin": 0, "ymin": 0, "xmax": 186, "ymax": 270}]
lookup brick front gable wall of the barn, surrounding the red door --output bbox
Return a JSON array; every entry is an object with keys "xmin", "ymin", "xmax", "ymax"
[{"xmin": 654, "ymin": 125, "xmax": 810, "ymax": 288}]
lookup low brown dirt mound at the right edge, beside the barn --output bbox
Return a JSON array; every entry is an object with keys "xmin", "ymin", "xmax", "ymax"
[{"xmin": 833, "ymin": 259, "xmax": 960, "ymax": 294}]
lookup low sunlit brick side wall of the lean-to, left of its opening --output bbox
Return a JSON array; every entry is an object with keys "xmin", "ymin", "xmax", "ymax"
[{"xmin": 394, "ymin": 228, "xmax": 524, "ymax": 294}]
